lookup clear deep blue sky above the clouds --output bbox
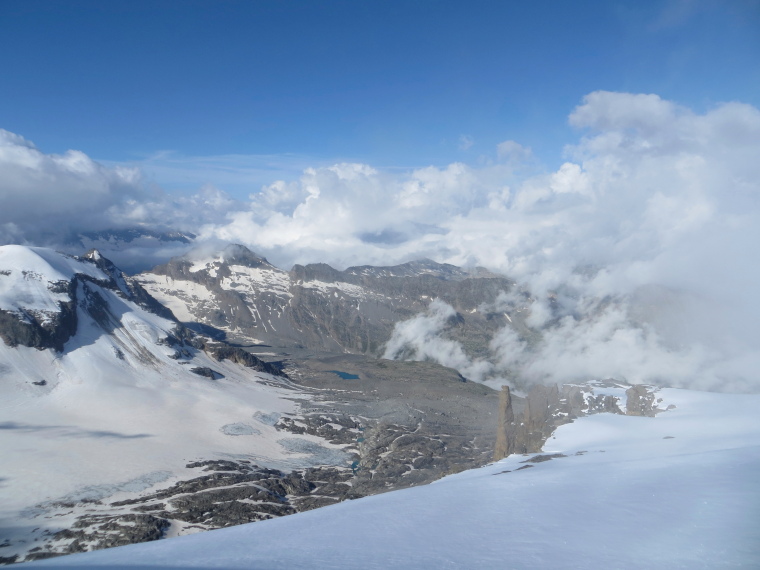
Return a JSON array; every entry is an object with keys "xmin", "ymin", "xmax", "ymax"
[{"xmin": 0, "ymin": 0, "xmax": 760, "ymax": 194}]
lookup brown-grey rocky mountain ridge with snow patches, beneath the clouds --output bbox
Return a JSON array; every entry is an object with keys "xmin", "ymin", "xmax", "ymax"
[{"xmin": 136, "ymin": 246, "xmax": 514, "ymax": 356}]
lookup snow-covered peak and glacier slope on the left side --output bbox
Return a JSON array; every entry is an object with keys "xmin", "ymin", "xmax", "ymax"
[{"xmin": 0, "ymin": 246, "xmax": 350, "ymax": 556}]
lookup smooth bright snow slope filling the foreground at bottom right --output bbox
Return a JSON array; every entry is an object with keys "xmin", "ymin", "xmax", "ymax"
[{"xmin": 17, "ymin": 389, "xmax": 760, "ymax": 570}]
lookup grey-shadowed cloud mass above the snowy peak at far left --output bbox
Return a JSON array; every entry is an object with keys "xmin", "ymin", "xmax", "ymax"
[{"xmin": 0, "ymin": 129, "xmax": 239, "ymax": 269}]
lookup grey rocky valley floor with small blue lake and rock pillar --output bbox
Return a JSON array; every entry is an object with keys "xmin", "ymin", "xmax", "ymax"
[{"xmin": 14, "ymin": 348, "xmax": 662, "ymax": 560}]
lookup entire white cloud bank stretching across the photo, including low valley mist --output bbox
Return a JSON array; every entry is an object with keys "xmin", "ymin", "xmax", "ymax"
[{"xmin": 0, "ymin": 91, "xmax": 760, "ymax": 389}]
